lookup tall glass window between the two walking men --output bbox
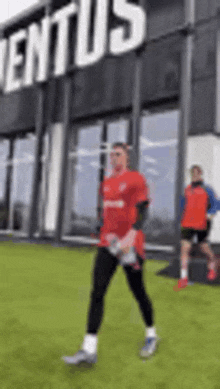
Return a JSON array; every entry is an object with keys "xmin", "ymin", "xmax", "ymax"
[{"xmin": 140, "ymin": 110, "xmax": 179, "ymax": 244}]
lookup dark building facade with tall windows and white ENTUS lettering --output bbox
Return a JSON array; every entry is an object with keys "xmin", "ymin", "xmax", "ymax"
[{"xmin": 0, "ymin": 0, "xmax": 220, "ymax": 249}]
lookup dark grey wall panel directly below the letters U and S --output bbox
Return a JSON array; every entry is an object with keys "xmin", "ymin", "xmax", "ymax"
[{"xmin": 72, "ymin": 53, "xmax": 134, "ymax": 119}]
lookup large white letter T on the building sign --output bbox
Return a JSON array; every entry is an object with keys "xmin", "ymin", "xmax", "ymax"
[{"xmin": 53, "ymin": 3, "xmax": 78, "ymax": 76}]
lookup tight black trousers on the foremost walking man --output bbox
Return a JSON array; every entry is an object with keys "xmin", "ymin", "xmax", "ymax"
[{"xmin": 87, "ymin": 247, "xmax": 153, "ymax": 334}]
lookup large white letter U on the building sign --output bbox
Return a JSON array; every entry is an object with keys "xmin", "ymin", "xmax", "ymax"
[{"xmin": 75, "ymin": 0, "xmax": 109, "ymax": 67}]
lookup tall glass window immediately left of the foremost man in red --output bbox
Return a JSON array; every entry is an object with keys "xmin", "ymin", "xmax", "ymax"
[{"xmin": 63, "ymin": 125, "xmax": 102, "ymax": 235}]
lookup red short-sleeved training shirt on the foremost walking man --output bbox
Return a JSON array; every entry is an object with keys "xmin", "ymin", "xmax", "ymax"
[{"xmin": 98, "ymin": 170, "xmax": 149, "ymax": 258}]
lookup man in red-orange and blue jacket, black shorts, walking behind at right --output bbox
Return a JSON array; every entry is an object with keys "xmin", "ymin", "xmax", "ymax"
[{"xmin": 177, "ymin": 165, "xmax": 217, "ymax": 289}]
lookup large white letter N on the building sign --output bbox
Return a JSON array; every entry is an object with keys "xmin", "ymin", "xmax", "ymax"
[{"xmin": 24, "ymin": 17, "xmax": 50, "ymax": 86}]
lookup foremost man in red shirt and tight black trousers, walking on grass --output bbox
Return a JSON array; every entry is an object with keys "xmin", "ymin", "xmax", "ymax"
[{"xmin": 63, "ymin": 143, "xmax": 158, "ymax": 365}]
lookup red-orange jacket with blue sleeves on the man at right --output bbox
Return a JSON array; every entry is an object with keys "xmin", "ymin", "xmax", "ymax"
[{"xmin": 181, "ymin": 181, "xmax": 217, "ymax": 230}]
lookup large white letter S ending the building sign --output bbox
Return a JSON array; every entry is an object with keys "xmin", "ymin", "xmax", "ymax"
[{"xmin": 110, "ymin": 0, "xmax": 147, "ymax": 55}]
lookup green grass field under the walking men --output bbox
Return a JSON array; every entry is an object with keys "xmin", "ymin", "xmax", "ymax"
[{"xmin": 0, "ymin": 242, "xmax": 220, "ymax": 389}]
